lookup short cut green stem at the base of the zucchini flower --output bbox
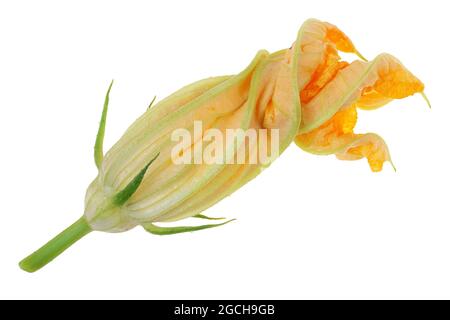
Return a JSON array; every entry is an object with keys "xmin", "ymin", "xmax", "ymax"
[{"xmin": 19, "ymin": 217, "xmax": 92, "ymax": 272}]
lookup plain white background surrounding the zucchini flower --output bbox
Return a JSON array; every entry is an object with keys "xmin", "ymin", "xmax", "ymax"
[{"xmin": 0, "ymin": 0, "xmax": 450, "ymax": 299}]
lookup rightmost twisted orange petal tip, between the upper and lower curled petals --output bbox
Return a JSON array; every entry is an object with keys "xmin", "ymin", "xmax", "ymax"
[{"xmin": 299, "ymin": 54, "xmax": 424, "ymax": 133}]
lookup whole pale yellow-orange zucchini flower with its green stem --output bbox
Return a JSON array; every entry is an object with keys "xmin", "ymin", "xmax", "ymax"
[{"xmin": 20, "ymin": 20, "xmax": 425, "ymax": 272}]
